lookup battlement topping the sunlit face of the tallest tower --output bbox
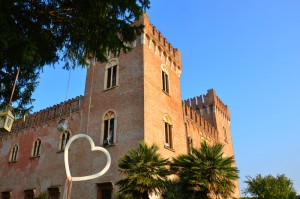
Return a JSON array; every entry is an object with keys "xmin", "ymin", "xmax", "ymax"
[{"xmin": 139, "ymin": 14, "xmax": 182, "ymax": 76}]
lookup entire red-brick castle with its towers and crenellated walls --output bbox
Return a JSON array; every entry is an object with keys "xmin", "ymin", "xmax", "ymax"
[{"xmin": 0, "ymin": 15, "xmax": 239, "ymax": 199}]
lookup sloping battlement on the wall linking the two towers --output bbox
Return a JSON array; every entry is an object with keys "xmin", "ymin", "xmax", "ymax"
[{"xmin": 182, "ymin": 102, "xmax": 218, "ymax": 140}]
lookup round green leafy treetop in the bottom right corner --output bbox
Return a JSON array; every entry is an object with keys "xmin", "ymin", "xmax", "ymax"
[{"xmin": 244, "ymin": 174, "xmax": 296, "ymax": 199}]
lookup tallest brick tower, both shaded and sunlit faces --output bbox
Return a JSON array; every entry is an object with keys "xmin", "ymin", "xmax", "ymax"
[{"xmin": 79, "ymin": 15, "xmax": 187, "ymax": 198}]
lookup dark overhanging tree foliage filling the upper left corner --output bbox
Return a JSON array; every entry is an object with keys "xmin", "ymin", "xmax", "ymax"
[{"xmin": 0, "ymin": 0, "xmax": 150, "ymax": 115}]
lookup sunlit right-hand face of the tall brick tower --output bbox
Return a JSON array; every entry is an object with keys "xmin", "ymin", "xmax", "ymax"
[{"xmin": 142, "ymin": 16, "xmax": 187, "ymax": 157}]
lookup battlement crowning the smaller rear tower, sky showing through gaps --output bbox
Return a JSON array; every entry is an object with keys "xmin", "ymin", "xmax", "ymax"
[{"xmin": 184, "ymin": 89, "xmax": 230, "ymax": 121}]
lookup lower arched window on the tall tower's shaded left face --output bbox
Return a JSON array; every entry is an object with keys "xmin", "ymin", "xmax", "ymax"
[{"xmin": 102, "ymin": 111, "xmax": 116, "ymax": 146}]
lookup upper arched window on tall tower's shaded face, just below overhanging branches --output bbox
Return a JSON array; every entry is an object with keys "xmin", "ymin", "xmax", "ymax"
[{"xmin": 104, "ymin": 58, "xmax": 119, "ymax": 89}]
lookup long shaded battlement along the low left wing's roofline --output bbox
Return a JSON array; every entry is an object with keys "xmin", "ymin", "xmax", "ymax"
[{"xmin": 0, "ymin": 96, "xmax": 84, "ymax": 137}]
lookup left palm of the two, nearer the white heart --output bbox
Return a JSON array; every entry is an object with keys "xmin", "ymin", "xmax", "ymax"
[{"xmin": 117, "ymin": 142, "xmax": 169, "ymax": 199}]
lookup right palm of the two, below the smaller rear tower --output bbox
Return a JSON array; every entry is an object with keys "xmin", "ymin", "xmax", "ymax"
[{"xmin": 171, "ymin": 142, "xmax": 238, "ymax": 199}]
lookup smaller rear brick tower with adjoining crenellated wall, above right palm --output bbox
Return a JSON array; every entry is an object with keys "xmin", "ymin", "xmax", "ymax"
[{"xmin": 183, "ymin": 89, "xmax": 240, "ymax": 198}]
